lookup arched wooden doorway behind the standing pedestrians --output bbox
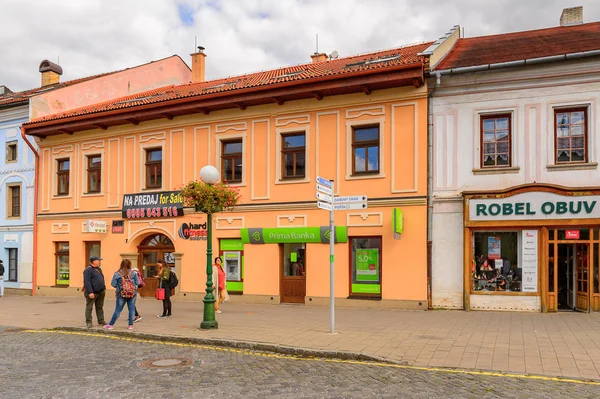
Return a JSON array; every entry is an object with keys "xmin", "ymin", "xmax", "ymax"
[{"xmin": 138, "ymin": 234, "xmax": 175, "ymax": 296}]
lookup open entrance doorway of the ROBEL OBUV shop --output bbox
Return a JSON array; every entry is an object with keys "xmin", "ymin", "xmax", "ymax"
[{"xmin": 557, "ymin": 243, "xmax": 590, "ymax": 312}]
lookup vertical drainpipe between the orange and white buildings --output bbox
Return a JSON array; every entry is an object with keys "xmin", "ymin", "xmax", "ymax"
[{"xmin": 427, "ymin": 73, "xmax": 440, "ymax": 309}]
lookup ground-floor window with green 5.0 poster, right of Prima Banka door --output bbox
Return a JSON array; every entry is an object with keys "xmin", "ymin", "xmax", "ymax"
[{"xmin": 350, "ymin": 237, "xmax": 381, "ymax": 297}]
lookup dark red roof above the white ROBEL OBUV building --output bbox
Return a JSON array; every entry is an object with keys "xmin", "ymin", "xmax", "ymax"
[{"xmin": 434, "ymin": 22, "xmax": 600, "ymax": 70}]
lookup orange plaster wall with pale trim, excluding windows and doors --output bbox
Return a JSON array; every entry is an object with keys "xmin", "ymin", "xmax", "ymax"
[{"xmin": 32, "ymin": 87, "xmax": 427, "ymax": 308}]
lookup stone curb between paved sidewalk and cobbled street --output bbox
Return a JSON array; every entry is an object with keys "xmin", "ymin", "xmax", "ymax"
[{"xmin": 54, "ymin": 327, "xmax": 408, "ymax": 366}]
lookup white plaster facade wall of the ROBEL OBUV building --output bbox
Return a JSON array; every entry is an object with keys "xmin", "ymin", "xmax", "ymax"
[{"xmin": 430, "ymin": 60, "xmax": 600, "ymax": 308}]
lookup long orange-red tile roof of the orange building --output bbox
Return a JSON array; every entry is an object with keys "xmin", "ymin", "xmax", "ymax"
[{"xmin": 30, "ymin": 42, "xmax": 432, "ymax": 124}]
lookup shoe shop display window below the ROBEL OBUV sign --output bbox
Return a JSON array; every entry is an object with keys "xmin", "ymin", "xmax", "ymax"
[{"xmin": 471, "ymin": 231, "xmax": 537, "ymax": 293}]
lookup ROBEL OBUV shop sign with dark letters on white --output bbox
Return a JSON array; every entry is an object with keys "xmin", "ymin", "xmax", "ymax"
[{"xmin": 467, "ymin": 192, "xmax": 600, "ymax": 221}]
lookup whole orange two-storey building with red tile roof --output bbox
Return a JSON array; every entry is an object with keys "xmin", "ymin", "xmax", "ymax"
[{"xmin": 24, "ymin": 43, "xmax": 431, "ymax": 309}]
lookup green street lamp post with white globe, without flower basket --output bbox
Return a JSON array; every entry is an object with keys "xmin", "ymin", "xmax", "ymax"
[{"xmin": 200, "ymin": 165, "xmax": 220, "ymax": 330}]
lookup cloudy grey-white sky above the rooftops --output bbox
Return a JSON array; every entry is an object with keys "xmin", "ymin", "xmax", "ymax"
[{"xmin": 0, "ymin": 0, "xmax": 600, "ymax": 91}]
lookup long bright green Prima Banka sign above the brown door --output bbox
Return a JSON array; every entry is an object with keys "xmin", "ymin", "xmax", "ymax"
[{"xmin": 240, "ymin": 226, "xmax": 348, "ymax": 244}]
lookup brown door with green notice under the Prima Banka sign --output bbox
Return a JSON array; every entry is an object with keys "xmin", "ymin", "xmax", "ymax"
[{"xmin": 279, "ymin": 244, "xmax": 306, "ymax": 303}]
